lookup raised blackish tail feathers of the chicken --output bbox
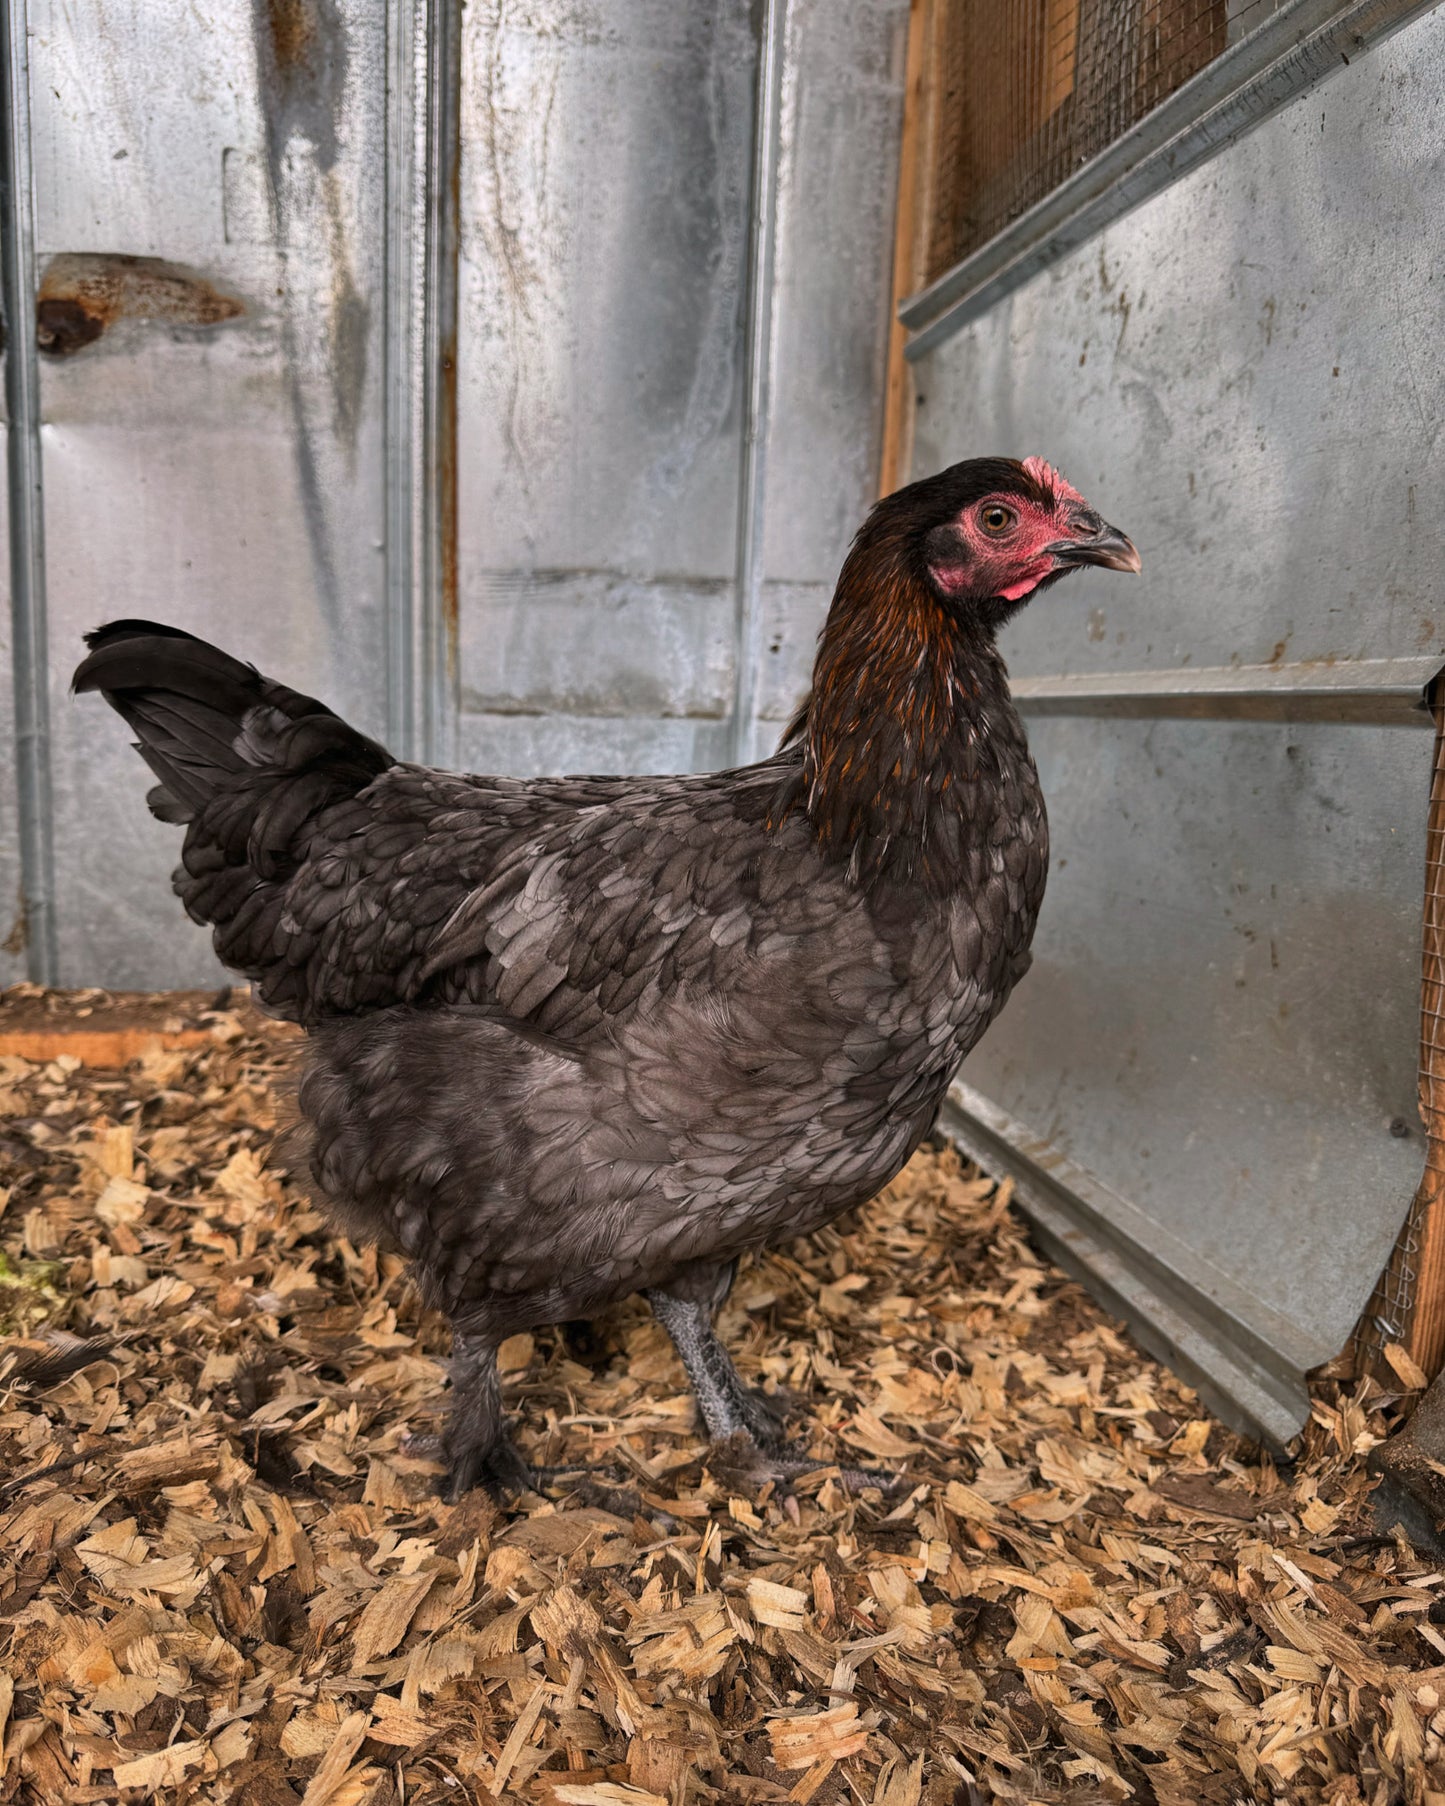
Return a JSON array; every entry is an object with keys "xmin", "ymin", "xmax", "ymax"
[{"xmin": 74, "ymin": 621, "xmax": 396, "ymax": 975}]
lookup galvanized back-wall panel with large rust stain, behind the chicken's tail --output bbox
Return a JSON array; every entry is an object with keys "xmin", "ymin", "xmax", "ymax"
[{"xmin": 31, "ymin": 0, "xmax": 387, "ymax": 986}]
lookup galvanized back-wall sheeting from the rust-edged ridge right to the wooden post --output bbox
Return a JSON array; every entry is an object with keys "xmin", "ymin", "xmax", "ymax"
[{"xmin": 459, "ymin": 0, "xmax": 907, "ymax": 773}]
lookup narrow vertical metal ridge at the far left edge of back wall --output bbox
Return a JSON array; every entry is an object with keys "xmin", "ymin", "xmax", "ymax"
[{"xmin": 0, "ymin": 0, "xmax": 60, "ymax": 984}]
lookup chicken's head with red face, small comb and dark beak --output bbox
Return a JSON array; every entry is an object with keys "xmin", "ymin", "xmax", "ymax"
[{"xmin": 910, "ymin": 457, "xmax": 1140, "ymax": 627}]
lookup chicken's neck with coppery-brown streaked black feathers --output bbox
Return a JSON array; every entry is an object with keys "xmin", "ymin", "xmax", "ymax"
[{"xmin": 798, "ymin": 547, "xmax": 1031, "ymax": 894}]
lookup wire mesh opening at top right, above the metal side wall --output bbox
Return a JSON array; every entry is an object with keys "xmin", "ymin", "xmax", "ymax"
[{"xmin": 923, "ymin": 0, "xmax": 1282, "ymax": 282}]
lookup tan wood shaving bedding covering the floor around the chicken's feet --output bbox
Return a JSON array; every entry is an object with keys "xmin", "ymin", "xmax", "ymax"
[{"xmin": 0, "ymin": 988, "xmax": 1445, "ymax": 1806}]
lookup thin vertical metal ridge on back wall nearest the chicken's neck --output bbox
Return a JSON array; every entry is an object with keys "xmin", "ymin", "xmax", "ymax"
[{"xmin": 730, "ymin": 0, "xmax": 788, "ymax": 764}]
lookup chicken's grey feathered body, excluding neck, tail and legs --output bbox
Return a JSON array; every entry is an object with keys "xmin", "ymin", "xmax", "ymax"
[{"xmin": 302, "ymin": 740, "xmax": 1044, "ymax": 1335}]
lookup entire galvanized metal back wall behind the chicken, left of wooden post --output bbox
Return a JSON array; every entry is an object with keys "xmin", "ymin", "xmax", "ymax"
[{"xmin": 0, "ymin": 0, "xmax": 907, "ymax": 986}]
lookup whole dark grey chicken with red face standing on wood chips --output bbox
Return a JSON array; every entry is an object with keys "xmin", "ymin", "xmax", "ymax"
[{"xmin": 76, "ymin": 459, "xmax": 1140, "ymax": 1497}]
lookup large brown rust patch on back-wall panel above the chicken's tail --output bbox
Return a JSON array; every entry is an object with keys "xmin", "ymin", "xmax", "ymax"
[{"xmin": 34, "ymin": 251, "xmax": 246, "ymax": 358}]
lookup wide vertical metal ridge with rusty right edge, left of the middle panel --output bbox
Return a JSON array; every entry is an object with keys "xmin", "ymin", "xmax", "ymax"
[{"xmin": 383, "ymin": 0, "xmax": 461, "ymax": 762}]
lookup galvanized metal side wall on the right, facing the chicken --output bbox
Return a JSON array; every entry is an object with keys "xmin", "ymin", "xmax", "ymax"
[{"xmin": 916, "ymin": 0, "xmax": 1445, "ymax": 1436}]
